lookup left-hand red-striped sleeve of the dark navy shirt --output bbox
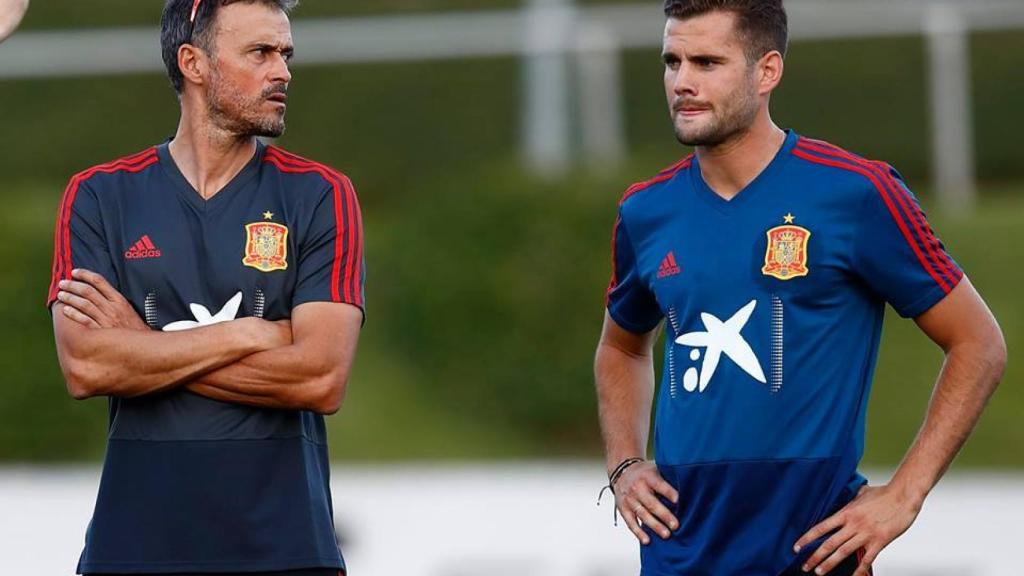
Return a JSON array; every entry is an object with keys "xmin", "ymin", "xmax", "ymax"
[{"xmin": 46, "ymin": 176, "xmax": 121, "ymax": 307}]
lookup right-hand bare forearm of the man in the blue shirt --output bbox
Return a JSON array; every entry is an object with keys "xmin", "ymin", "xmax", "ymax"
[{"xmin": 890, "ymin": 343, "xmax": 1005, "ymax": 502}]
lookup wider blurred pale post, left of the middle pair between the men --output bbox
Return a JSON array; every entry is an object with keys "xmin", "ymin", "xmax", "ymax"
[{"xmin": 522, "ymin": 0, "xmax": 573, "ymax": 176}]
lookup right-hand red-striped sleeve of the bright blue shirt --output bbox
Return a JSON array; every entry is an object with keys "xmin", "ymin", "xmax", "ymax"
[{"xmin": 853, "ymin": 164, "xmax": 964, "ymax": 318}]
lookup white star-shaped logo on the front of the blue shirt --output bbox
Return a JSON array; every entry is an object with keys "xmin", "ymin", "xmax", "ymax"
[{"xmin": 676, "ymin": 299, "xmax": 767, "ymax": 392}]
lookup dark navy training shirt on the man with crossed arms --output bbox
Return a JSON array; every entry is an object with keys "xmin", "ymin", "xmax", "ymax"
[{"xmin": 47, "ymin": 143, "xmax": 364, "ymax": 573}]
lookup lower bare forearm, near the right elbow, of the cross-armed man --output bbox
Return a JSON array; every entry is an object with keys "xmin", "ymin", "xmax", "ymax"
[{"xmin": 186, "ymin": 343, "xmax": 348, "ymax": 414}]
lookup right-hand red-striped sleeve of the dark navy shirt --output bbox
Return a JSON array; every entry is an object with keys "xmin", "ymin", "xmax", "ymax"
[{"xmin": 292, "ymin": 173, "xmax": 366, "ymax": 310}]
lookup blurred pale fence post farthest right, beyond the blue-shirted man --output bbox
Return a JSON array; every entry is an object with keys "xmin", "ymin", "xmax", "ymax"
[{"xmin": 925, "ymin": 3, "xmax": 977, "ymax": 212}]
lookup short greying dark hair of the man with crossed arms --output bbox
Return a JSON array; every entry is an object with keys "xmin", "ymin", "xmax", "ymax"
[{"xmin": 160, "ymin": 0, "xmax": 299, "ymax": 94}]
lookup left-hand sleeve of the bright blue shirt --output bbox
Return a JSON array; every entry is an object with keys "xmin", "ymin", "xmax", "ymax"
[{"xmin": 607, "ymin": 210, "xmax": 663, "ymax": 334}]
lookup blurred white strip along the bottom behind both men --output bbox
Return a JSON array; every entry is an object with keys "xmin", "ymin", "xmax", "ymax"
[{"xmin": 0, "ymin": 461, "xmax": 1024, "ymax": 576}]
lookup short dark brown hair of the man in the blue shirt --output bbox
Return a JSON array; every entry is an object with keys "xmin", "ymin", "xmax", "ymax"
[{"xmin": 665, "ymin": 0, "xmax": 790, "ymax": 61}]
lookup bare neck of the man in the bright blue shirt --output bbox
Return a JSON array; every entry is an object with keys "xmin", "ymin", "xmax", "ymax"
[{"xmin": 696, "ymin": 112, "xmax": 785, "ymax": 200}]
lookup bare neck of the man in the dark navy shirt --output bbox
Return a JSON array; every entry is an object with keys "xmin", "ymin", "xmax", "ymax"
[{"xmin": 168, "ymin": 97, "xmax": 256, "ymax": 200}]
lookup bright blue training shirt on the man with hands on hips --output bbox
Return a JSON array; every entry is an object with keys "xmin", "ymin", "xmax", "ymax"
[{"xmin": 607, "ymin": 131, "xmax": 963, "ymax": 576}]
